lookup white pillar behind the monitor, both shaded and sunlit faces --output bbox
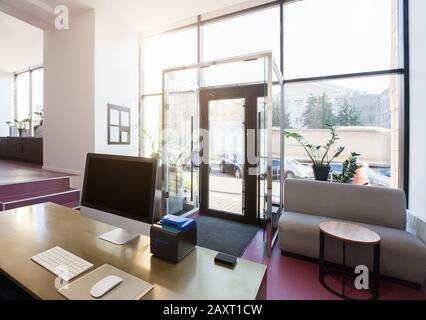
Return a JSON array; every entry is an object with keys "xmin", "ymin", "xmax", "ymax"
[{"xmin": 43, "ymin": 10, "xmax": 139, "ymax": 174}]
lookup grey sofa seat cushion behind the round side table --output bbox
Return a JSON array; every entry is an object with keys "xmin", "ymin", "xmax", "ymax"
[{"xmin": 279, "ymin": 212, "xmax": 426, "ymax": 284}]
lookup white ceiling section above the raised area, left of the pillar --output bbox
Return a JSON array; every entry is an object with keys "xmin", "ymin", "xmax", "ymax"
[{"xmin": 0, "ymin": 12, "xmax": 43, "ymax": 72}]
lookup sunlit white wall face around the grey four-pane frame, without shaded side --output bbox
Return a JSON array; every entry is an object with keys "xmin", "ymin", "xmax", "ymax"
[{"xmin": 95, "ymin": 10, "xmax": 139, "ymax": 156}]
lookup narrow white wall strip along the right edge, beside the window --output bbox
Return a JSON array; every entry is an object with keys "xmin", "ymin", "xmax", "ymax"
[{"xmin": 410, "ymin": 0, "xmax": 426, "ymax": 219}]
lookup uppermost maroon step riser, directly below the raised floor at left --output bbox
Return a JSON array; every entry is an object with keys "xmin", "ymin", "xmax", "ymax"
[{"xmin": 0, "ymin": 176, "xmax": 70, "ymax": 201}]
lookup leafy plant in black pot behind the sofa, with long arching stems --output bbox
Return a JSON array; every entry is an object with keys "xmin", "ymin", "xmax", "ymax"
[{"xmin": 284, "ymin": 125, "xmax": 345, "ymax": 181}]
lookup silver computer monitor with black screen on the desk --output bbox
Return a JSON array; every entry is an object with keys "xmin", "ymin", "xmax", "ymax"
[{"xmin": 81, "ymin": 153, "xmax": 157, "ymax": 245}]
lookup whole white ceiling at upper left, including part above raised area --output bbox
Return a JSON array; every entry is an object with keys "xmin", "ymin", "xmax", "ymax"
[{"xmin": 0, "ymin": 0, "xmax": 253, "ymax": 72}]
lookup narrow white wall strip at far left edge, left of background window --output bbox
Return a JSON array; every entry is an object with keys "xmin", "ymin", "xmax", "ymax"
[{"xmin": 0, "ymin": 71, "xmax": 14, "ymax": 137}]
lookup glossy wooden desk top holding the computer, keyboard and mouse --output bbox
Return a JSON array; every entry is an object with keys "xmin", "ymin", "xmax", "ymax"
[{"xmin": 0, "ymin": 203, "xmax": 266, "ymax": 300}]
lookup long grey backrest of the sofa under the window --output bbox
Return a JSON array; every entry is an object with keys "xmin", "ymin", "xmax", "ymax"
[{"xmin": 284, "ymin": 179, "xmax": 407, "ymax": 230}]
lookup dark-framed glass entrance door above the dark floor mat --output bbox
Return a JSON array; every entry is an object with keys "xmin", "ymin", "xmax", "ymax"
[{"xmin": 200, "ymin": 85, "xmax": 265, "ymax": 224}]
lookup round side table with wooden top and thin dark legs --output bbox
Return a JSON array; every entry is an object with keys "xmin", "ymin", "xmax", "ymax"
[{"xmin": 319, "ymin": 221, "xmax": 380, "ymax": 300}]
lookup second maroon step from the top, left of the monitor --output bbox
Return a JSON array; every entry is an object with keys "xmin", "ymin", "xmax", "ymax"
[{"xmin": 0, "ymin": 188, "xmax": 80, "ymax": 211}]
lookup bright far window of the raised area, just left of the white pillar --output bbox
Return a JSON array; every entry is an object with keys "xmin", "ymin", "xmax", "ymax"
[{"xmin": 15, "ymin": 68, "xmax": 43, "ymax": 132}]
